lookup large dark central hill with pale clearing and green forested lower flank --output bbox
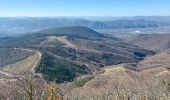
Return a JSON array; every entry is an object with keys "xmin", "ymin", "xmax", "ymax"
[{"xmin": 0, "ymin": 26, "xmax": 155, "ymax": 82}]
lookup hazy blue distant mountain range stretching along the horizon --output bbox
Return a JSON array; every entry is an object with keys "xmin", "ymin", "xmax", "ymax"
[{"xmin": 0, "ymin": 17, "xmax": 170, "ymax": 34}]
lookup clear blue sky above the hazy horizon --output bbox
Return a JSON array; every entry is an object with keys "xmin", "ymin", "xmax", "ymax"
[{"xmin": 0, "ymin": 0, "xmax": 170, "ymax": 17}]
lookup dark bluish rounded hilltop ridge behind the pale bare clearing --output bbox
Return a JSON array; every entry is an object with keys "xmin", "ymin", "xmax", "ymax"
[{"xmin": 0, "ymin": 26, "xmax": 104, "ymax": 47}]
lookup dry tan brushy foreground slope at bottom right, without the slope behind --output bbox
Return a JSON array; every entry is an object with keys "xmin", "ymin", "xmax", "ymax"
[{"xmin": 65, "ymin": 66, "xmax": 170, "ymax": 100}]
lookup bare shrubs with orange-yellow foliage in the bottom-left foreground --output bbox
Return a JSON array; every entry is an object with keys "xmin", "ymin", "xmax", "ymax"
[{"xmin": 0, "ymin": 74, "xmax": 65, "ymax": 100}]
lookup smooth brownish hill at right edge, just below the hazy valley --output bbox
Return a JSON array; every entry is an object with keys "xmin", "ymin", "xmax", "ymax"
[{"xmin": 130, "ymin": 34, "xmax": 170, "ymax": 52}]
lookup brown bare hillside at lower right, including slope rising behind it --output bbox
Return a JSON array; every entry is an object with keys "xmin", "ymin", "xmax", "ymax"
[{"xmin": 65, "ymin": 48, "xmax": 170, "ymax": 100}]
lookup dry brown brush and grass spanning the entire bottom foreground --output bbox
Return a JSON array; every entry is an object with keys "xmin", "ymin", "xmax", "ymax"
[{"xmin": 0, "ymin": 66, "xmax": 170, "ymax": 100}]
